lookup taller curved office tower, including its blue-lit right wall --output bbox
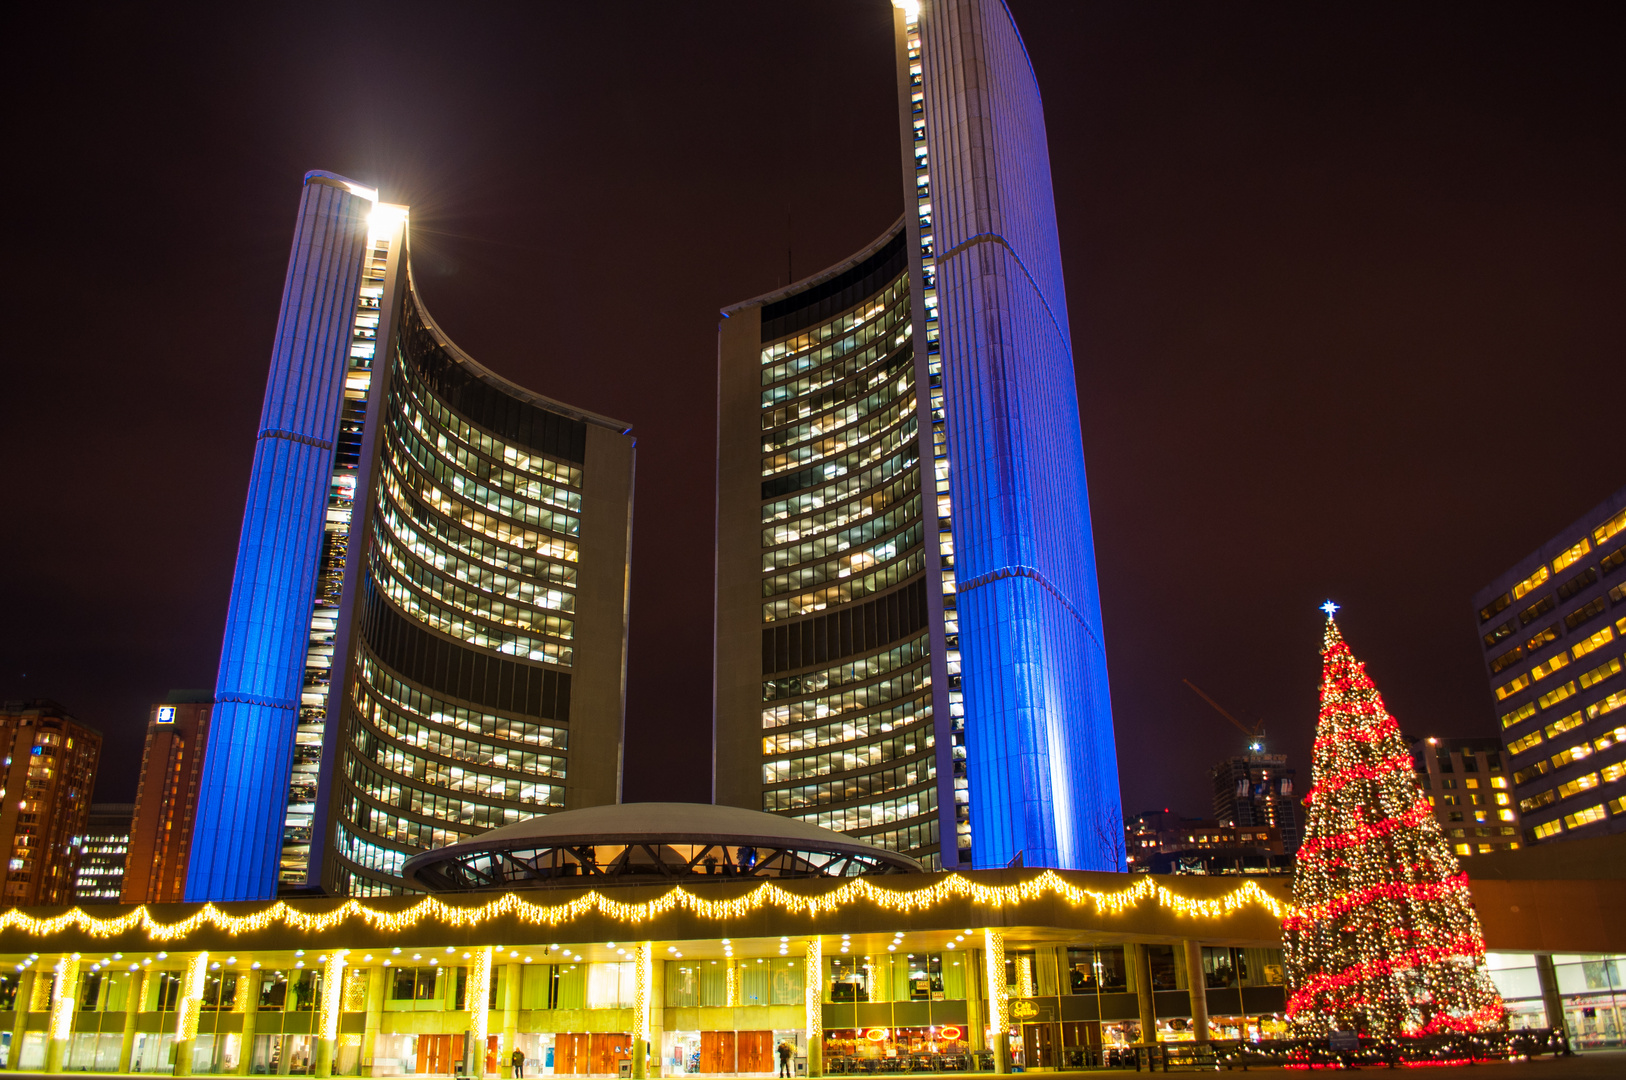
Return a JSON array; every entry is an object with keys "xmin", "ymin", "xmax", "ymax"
[{"xmin": 714, "ymin": 0, "xmax": 1124, "ymax": 870}]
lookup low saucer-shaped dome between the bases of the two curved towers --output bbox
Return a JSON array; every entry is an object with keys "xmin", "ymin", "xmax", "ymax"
[{"xmin": 402, "ymin": 802, "xmax": 922, "ymax": 891}]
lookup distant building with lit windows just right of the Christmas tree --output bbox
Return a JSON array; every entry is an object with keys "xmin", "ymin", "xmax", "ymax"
[{"xmin": 1411, "ymin": 738, "xmax": 1520, "ymax": 856}]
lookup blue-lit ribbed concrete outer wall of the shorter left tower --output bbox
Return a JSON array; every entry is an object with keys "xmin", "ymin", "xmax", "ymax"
[{"xmin": 185, "ymin": 174, "xmax": 372, "ymax": 899}]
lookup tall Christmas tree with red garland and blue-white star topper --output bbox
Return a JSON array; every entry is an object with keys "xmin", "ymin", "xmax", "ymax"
[{"xmin": 1281, "ymin": 600, "xmax": 1504, "ymax": 1039}]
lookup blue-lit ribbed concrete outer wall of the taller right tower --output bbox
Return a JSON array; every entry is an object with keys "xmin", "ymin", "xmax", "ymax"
[{"xmin": 920, "ymin": 0, "xmax": 1124, "ymax": 870}]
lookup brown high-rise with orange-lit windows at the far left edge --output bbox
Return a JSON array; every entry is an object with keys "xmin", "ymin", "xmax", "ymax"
[{"xmin": 0, "ymin": 699, "xmax": 101, "ymax": 908}]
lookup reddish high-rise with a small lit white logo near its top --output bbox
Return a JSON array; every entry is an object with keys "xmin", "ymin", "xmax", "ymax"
[{"xmin": 124, "ymin": 690, "xmax": 215, "ymax": 904}]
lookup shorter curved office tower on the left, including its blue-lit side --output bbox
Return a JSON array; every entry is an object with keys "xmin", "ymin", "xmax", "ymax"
[{"xmin": 187, "ymin": 172, "xmax": 633, "ymax": 899}]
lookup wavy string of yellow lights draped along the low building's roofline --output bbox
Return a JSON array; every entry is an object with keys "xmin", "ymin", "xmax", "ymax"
[{"xmin": 0, "ymin": 870, "xmax": 1285, "ymax": 942}]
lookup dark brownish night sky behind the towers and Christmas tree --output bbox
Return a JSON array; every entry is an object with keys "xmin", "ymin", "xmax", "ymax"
[{"xmin": 0, "ymin": 0, "xmax": 1626, "ymax": 826}]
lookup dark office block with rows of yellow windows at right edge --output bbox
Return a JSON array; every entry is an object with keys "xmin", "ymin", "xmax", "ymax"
[{"xmin": 1473, "ymin": 488, "xmax": 1626, "ymax": 844}]
